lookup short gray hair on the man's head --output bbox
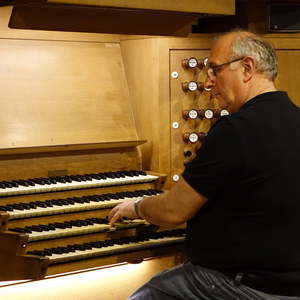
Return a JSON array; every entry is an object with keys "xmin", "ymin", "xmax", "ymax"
[{"xmin": 230, "ymin": 32, "xmax": 278, "ymax": 81}]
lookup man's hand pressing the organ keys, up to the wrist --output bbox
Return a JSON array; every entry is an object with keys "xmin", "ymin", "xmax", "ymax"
[{"xmin": 108, "ymin": 200, "xmax": 139, "ymax": 225}]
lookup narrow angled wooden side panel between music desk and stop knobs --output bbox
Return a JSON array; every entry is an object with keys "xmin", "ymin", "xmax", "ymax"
[{"xmin": 121, "ymin": 38, "xmax": 162, "ymax": 171}]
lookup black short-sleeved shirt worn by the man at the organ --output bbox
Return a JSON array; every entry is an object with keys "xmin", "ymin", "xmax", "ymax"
[{"xmin": 183, "ymin": 92, "xmax": 300, "ymax": 295}]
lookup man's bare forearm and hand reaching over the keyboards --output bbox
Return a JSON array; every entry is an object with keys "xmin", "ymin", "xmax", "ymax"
[{"xmin": 109, "ymin": 177, "xmax": 207, "ymax": 226}]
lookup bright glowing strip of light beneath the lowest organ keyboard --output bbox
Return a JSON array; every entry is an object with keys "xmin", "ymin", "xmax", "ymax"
[{"xmin": 0, "ymin": 258, "xmax": 169, "ymax": 300}]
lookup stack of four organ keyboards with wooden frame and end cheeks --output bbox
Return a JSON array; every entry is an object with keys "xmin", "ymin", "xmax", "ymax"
[{"xmin": 0, "ymin": 170, "xmax": 184, "ymax": 280}]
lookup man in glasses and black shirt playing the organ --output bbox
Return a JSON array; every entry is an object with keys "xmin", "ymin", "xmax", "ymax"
[{"xmin": 109, "ymin": 31, "xmax": 300, "ymax": 300}]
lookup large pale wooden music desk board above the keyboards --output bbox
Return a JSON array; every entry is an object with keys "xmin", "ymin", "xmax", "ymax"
[{"xmin": 0, "ymin": 40, "xmax": 137, "ymax": 148}]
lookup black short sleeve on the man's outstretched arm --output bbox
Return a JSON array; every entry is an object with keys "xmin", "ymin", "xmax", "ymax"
[{"xmin": 182, "ymin": 117, "xmax": 243, "ymax": 199}]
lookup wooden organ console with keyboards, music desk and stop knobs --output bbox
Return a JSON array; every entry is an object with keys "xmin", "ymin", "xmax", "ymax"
[{"xmin": 0, "ymin": 9, "xmax": 227, "ymax": 289}]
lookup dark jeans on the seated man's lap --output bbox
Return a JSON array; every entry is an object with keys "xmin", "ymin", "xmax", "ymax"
[{"xmin": 128, "ymin": 263, "xmax": 300, "ymax": 300}]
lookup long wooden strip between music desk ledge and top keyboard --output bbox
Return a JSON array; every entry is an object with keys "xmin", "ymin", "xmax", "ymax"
[{"xmin": 0, "ymin": 148, "xmax": 141, "ymax": 180}]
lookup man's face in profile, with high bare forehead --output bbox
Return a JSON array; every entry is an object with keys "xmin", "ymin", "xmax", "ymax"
[{"xmin": 206, "ymin": 36, "xmax": 242, "ymax": 113}]
